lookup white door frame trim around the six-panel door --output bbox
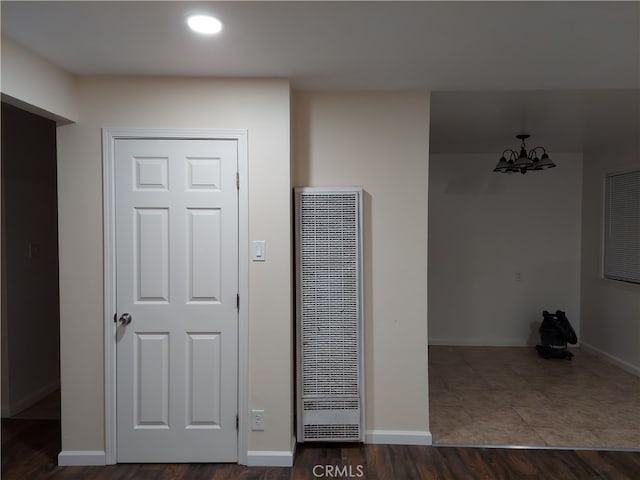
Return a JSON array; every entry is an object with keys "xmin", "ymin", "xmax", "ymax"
[{"xmin": 102, "ymin": 128, "xmax": 249, "ymax": 465}]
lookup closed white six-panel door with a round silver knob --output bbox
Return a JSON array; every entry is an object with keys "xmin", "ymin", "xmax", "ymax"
[{"xmin": 114, "ymin": 139, "xmax": 238, "ymax": 462}]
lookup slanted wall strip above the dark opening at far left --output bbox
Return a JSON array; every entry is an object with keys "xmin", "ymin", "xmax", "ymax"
[{"xmin": 0, "ymin": 35, "xmax": 77, "ymax": 124}]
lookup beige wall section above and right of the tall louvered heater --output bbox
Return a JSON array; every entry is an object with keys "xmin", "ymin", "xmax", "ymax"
[{"xmin": 292, "ymin": 92, "xmax": 429, "ymax": 432}]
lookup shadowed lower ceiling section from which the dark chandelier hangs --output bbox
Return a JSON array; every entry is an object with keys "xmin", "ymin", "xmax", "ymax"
[{"xmin": 430, "ymin": 89, "xmax": 640, "ymax": 153}]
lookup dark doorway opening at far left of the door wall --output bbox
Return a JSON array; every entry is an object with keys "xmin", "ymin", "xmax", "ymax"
[{"xmin": 1, "ymin": 102, "xmax": 60, "ymax": 420}]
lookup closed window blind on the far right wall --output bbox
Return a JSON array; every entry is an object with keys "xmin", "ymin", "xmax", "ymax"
[{"xmin": 604, "ymin": 170, "xmax": 640, "ymax": 283}]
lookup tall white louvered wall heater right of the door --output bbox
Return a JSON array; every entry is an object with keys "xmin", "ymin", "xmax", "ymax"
[{"xmin": 295, "ymin": 187, "xmax": 364, "ymax": 442}]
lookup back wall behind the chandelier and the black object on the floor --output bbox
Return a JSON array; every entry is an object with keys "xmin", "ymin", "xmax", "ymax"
[{"xmin": 429, "ymin": 154, "xmax": 582, "ymax": 346}]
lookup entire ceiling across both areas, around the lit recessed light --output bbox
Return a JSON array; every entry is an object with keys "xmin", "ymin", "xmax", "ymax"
[{"xmin": 1, "ymin": 1, "xmax": 640, "ymax": 152}]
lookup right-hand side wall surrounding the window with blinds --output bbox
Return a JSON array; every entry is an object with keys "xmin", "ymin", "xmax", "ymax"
[{"xmin": 581, "ymin": 138, "xmax": 640, "ymax": 374}]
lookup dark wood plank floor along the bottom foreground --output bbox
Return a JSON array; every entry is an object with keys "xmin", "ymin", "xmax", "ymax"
[{"xmin": 2, "ymin": 419, "xmax": 640, "ymax": 480}]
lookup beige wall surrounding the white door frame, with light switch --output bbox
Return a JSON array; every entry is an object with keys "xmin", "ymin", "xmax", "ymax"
[{"xmin": 58, "ymin": 77, "xmax": 293, "ymax": 451}]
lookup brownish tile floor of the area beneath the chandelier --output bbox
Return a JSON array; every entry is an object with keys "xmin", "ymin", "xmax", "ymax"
[{"xmin": 429, "ymin": 346, "xmax": 640, "ymax": 450}]
